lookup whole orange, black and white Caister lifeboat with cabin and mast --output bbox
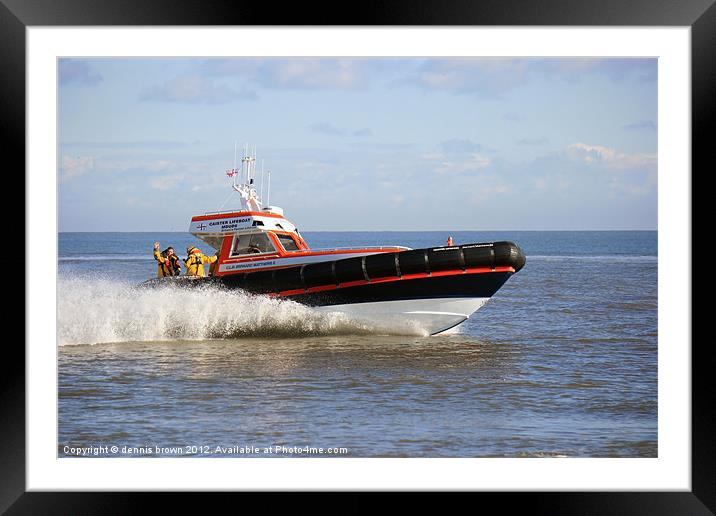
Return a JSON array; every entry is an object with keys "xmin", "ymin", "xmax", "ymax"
[{"xmin": 144, "ymin": 146, "xmax": 525, "ymax": 334}]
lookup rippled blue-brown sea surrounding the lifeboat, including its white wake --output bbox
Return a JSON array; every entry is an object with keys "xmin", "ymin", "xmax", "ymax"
[{"xmin": 57, "ymin": 231, "xmax": 658, "ymax": 458}]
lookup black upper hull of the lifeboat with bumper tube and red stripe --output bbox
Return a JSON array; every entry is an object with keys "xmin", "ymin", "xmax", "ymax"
[{"xmin": 143, "ymin": 242, "xmax": 525, "ymax": 306}]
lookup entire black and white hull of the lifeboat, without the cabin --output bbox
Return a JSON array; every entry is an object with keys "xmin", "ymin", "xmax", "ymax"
[{"xmin": 140, "ymin": 242, "xmax": 525, "ymax": 334}]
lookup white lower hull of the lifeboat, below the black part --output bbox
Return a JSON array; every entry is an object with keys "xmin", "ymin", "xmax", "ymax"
[{"xmin": 315, "ymin": 297, "xmax": 490, "ymax": 335}]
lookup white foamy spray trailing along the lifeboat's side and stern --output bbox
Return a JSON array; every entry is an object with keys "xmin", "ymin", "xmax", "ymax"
[{"xmin": 57, "ymin": 277, "xmax": 425, "ymax": 345}]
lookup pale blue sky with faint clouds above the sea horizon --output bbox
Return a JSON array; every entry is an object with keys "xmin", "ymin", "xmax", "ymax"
[{"xmin": 57, "ymin": 58, "xmax": 657, "ymax": 232}]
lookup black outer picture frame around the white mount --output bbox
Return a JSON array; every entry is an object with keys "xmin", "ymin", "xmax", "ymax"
[{"xmin": 5, "ymin": 0, "xmax": 716, "ymax": 514}]
